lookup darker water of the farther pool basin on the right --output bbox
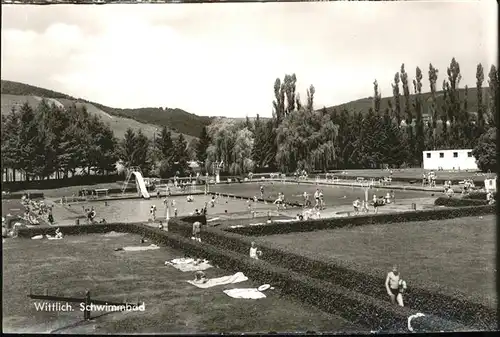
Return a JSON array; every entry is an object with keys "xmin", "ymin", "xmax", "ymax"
[{"xmin": 210, "ymin": 182, "xmax": 436, "ymax": 206}]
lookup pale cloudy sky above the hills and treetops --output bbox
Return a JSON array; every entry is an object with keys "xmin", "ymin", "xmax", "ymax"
[{"xmin": 1, "ymin": 0, "xmax": 498, "ymax": 117}]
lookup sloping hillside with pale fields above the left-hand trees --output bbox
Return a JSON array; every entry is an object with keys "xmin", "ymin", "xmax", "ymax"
[{"xmin": 1, "ymin": 80, "xmax": 212, "ymax": 140}]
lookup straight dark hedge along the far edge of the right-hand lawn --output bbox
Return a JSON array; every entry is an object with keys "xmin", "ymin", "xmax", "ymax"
[{"xmin": 225, "ymin": 205, "xmax": 495, "ymax": 236}]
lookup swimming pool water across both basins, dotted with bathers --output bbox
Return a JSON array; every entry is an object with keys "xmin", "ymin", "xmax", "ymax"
[{"xmin": 56, "ymin": 183, "xmax": 432, "ymax": 223}]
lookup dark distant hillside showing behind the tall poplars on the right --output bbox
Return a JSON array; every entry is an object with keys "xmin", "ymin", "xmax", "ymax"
[{"xmin": 326, "ymin": 88, "xmax": 488, "ymax": 117}]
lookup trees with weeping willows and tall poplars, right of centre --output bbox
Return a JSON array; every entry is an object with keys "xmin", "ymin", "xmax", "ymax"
[{"xmin": 197, "ymin": 58, "xmax": 499, "ymax": 174}]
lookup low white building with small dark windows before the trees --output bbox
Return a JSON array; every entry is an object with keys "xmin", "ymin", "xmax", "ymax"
[{"xmin": 423, "ymin": 149, "xmax": 479, "ymax": 171}]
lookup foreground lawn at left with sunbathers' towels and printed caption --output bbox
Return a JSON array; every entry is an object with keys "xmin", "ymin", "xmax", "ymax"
[{"xmin": 2, "ymin": 234, "xmax": 362, "ymax": 334}]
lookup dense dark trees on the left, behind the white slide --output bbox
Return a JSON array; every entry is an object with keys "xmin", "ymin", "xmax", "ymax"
[{"xmin": 1, "ymin": 100, "xmax": 189, "ymax": 181}]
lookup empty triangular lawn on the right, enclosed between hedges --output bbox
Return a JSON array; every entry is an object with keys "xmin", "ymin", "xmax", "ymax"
[{"xmin": 258, "ymin": 215, "xmax": 497, "ymax": 306}]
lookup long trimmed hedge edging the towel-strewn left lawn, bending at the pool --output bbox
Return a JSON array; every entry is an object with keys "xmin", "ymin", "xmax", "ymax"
[{"xmin": 14, "ymin": 223, "xmax": 467, "ymax": 332}]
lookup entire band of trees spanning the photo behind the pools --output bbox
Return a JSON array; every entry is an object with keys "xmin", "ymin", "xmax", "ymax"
[{"xmin": 1, "ymin": 59, "xmax": 500, "ymax": 180}]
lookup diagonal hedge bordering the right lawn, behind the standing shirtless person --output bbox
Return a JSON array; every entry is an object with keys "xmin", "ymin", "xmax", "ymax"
[{"xmin": 173, "ymin": 215, "xmax": 496, "ymax": 329}]
